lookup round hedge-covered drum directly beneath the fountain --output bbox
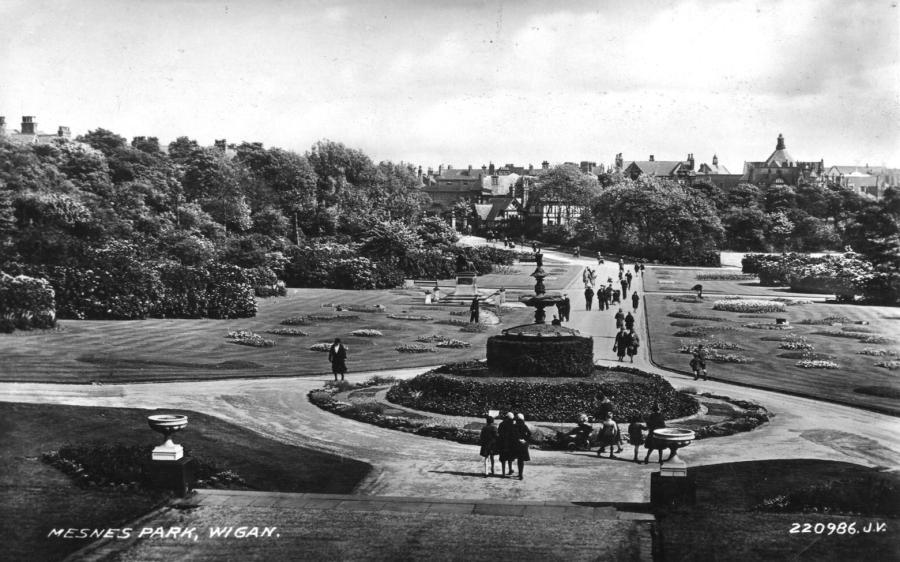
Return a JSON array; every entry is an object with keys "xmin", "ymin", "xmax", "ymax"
[{"xmin": 487, "ymin": 324, "xmax": 594, "ymax": 377}]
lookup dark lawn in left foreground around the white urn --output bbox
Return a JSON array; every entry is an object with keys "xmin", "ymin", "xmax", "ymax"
[{"xmin": 0, "ymin": 402, "xmax": 371, "ymax": 560}]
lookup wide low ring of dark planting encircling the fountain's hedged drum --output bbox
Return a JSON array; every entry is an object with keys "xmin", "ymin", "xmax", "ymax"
[{"xmin": 387, "ymin": 363, "xmax": 699, "ymax": 423}]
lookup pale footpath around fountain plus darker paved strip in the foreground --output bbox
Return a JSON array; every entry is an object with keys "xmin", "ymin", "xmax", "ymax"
[{"xmin": 0, "ymin": 240, "xmax": 900, "ymax": 560}]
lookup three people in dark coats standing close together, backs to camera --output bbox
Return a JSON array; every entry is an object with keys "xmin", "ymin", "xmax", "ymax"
[{"xmin": 479, "ymin": 412, "xmax": 531, "ymax": 480}]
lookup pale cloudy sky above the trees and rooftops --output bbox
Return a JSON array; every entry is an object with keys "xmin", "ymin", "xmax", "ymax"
[{"xmin": 0, "ymin": 0, "xmax": 900, "ymax": 173}]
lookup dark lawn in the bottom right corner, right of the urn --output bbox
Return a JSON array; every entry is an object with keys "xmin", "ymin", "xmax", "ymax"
[{"xmin": 657, "ymin": 459, "xmax": 900, "ymax": 562}]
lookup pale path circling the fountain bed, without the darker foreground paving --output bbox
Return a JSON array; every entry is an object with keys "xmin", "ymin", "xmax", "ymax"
[{"xmin": 0, "ymin": 241, "xmax": 900, "ymax": 502}]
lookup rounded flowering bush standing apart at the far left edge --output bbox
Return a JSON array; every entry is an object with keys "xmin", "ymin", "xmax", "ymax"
[{"xmin": 0, "ymin": 272, "xmax": 56, "ymax": 332}]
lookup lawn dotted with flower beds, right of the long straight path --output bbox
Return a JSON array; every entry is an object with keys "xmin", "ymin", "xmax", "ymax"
[{"xmin": 645, "ymin": 266, "xmax": 900, "ymax": 415}]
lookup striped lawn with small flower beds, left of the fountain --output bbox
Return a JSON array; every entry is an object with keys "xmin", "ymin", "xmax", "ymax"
[{"xmin": 0, "ymin": 289, "xmax": 533, "ymax": 383}]
